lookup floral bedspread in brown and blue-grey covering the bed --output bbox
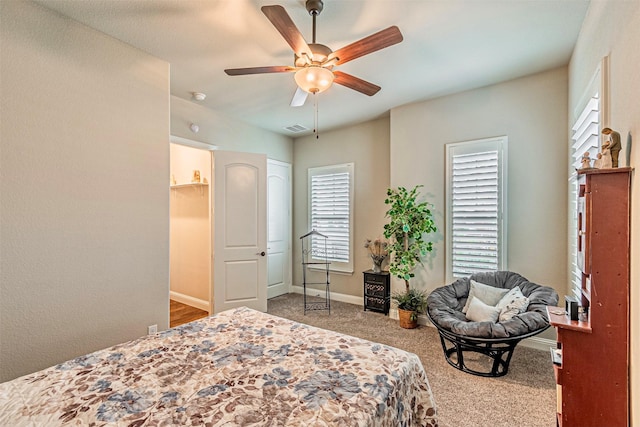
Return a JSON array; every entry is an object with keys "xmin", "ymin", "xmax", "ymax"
[{"xmin": 0, "ymin": 307, "xmax": 437, "ymax": 427}]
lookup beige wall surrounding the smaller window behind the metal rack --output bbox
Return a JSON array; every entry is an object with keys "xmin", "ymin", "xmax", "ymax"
[{"xmin": 292, "ymin": 118, "xmax": 389, "ymax": 296}]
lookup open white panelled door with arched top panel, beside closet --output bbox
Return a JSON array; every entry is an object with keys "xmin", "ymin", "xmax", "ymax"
[{"xmin": 212, "ymin": 151, "xmax": 267, "ymax": 313}]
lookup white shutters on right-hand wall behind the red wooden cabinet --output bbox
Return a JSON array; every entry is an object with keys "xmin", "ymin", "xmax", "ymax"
[{"xmin": 569, "ymin": 93, "xmax": 600, "ymax": 296}]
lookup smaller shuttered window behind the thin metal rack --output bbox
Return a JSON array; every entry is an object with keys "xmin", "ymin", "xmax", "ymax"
[{"xmin": 309, "ymin": 163, "xmax": 354, "ymax": 273}]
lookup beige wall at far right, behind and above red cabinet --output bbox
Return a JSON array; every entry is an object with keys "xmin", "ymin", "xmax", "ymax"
[{"xmin": 569, "ymin": 0, "xmax": 640, "ymax": 425}]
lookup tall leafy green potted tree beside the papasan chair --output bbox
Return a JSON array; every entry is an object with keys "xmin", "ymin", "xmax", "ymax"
[{"xmin": 384, "ymin": 185, "xmax": 436, "ymax": 327}]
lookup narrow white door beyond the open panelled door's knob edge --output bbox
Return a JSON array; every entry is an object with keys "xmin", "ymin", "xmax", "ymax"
[{"xmin": 267, "ymin": 160, "xmax": 291, "ymax": 298}]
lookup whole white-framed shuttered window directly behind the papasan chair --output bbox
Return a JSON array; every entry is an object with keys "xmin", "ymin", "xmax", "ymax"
[{"xmin": 446, "ymin": 136, "xmax": 507, "ymax": 279}]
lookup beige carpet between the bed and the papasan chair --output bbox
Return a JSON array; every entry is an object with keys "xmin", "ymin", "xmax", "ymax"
[{"xmin": 268, "ymin": 294, "xmax": 556, "ymax": 427}]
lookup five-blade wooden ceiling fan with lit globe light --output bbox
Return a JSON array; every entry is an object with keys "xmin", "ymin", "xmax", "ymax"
[{"xmin": 224, "ymin": 0, "xmax": 402, "ymax": 107}]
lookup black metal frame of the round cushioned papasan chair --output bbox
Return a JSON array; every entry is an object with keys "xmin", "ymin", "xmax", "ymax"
[{"xmin": 427, "ymin": 310, "xmax": 549, "ymax": 377}]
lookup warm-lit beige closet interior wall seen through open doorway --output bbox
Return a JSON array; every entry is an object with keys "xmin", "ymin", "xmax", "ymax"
[{"xmin": 169, "ymin": 144, "xmax": 211, "ymax": 304}]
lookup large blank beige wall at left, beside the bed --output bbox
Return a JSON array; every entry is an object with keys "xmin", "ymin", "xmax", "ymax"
[{"xmin": 0, "ymin": 1, "xmax": 169, "ymax": 381}]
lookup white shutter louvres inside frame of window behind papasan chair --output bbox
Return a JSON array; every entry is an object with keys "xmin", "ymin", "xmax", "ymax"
[{"xmin": 452, "ymin": 151, "xmax": 499, "ymax": 277}]
